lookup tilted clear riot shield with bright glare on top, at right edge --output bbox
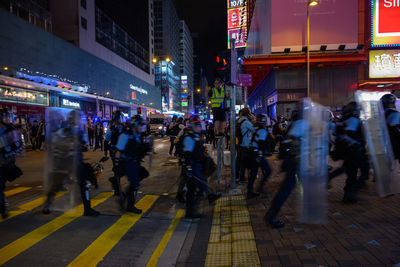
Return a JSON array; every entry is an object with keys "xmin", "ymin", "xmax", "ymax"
[{"xmin": 355, "ymin": 91, "xmax": 400, "ymax": 197}]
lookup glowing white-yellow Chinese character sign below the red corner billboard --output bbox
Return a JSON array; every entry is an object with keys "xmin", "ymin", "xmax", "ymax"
[{"xmin": 369, "ymin": 50, "xmax": 400, "ymax": 78}]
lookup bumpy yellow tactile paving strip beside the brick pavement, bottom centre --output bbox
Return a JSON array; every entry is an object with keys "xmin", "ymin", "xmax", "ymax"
[{"xmin": 205, "ymin": 195, "xmax": 261, "ymax": 267}]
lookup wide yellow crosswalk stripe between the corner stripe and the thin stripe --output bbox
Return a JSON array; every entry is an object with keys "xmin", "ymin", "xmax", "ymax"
[{"xmin": 68, "ymin": 195, "xmax": 158, "ymax": 267}]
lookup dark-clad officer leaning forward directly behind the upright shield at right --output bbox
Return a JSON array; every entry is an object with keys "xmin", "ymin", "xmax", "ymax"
[{"xmin": 264, "ymin": 111, "xmax": 305, "ymax": 228}]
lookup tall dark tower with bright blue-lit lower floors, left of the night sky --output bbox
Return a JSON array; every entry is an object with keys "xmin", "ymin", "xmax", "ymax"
[{"xmin": 154, "ymin": 0, "xmax": 181, "ymax": 111}]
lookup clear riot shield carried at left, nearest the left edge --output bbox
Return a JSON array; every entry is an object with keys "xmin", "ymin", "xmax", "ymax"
[{"xmin": 44, "ymin": 107, "xmax": 81, "ymax": 210}]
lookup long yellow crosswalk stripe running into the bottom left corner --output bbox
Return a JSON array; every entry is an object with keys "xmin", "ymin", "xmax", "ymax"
[{"xmin": 0, "ymin": 192, "xmax": 113, "ymax": 265}]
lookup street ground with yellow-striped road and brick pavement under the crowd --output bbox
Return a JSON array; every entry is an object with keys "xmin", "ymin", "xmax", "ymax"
[{"xmin": 0, "ymin": 138, "xmax": 400, "ymax": 266}]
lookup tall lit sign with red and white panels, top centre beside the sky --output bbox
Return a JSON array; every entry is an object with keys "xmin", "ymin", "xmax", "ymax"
[{"xmin": 227, "ymin": 0, "xmax": 247, "ymax": 49}]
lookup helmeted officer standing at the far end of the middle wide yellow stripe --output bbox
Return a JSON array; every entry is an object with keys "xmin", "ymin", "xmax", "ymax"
[{"xmin": 115, "ymin": 115, "xmax": 150, "ymax": 214}]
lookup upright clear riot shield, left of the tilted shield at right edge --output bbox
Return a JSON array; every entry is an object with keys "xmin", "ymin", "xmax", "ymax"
[{"xmin": 299, "ymin": 98, "xmax": 329, "ymax": 224}]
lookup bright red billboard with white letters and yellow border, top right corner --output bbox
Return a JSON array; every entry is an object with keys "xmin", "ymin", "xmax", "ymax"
[{"xmin": 371, "ymin": 0, "xmax": 400, "ymax": 47}]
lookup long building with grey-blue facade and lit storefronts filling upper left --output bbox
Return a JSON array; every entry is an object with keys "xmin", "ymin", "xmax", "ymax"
[{"xmin": 0, "ymin": 0, "xmax": 159, "ymax": 118}]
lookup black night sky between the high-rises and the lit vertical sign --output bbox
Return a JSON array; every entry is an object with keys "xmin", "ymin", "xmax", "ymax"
[{"xmin": 176, "ymin": 0, "xmax": 227, "ymax": 83}]
